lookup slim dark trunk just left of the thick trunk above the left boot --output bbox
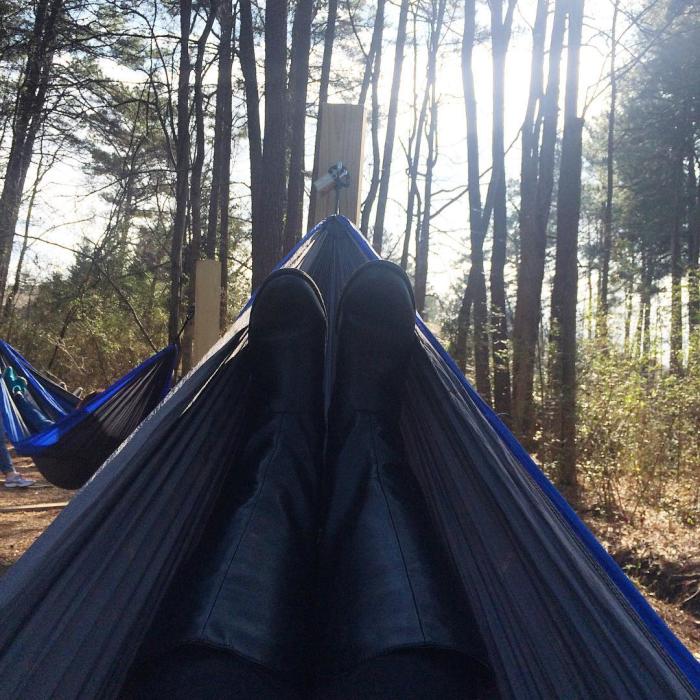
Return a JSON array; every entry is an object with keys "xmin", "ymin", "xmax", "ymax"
[{"xmin": 238, "ymin": 0, "xmax": 265, "ymax": 266}]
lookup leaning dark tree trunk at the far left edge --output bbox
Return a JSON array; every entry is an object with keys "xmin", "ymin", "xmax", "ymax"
[{"xmin": 0, "ymin": 0, "xmax": 63, "ymax": 301}]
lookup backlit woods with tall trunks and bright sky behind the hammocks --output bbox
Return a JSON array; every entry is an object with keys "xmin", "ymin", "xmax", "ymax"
[{"xmin": 0, "ymin": 0, "xmax": 700, "ymax": 640}]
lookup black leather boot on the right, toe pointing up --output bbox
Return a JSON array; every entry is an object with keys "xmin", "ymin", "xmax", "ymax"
[{"xmin": 317, "ymin": 261, "xmax": 486, "ymax": 698}]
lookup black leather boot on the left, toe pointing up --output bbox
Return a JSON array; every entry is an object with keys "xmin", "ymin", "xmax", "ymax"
[{"xmin": 126, "ymin": 269, "xmax": 326, "ymax": 698}]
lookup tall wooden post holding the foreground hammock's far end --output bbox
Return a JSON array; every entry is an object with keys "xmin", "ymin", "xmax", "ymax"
[{"xmin": 311, "ymin": 104, "xmax": 365, "ymax": 224}]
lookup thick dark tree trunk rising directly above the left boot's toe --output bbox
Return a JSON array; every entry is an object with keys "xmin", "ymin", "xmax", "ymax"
[{"xmin": 253, "ymin": 0, "xmax": 287, "ymax": 288}]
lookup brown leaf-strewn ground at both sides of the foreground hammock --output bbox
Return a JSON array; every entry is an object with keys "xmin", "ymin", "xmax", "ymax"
[{"xmin": 0, "ymin": 457, "xmax": 700, "ymax": 659}]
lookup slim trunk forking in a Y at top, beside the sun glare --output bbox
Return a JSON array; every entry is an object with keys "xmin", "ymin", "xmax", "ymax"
[{"xmin": 489, "ymin": 0, "xmax": 516, "ymax": 420}]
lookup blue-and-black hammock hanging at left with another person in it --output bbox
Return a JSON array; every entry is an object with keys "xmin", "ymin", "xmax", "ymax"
[{"xmin": 0, "ymin": 340, "xmax": 177, "ymax": 489}]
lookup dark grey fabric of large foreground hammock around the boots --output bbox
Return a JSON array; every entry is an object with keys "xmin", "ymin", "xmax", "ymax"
[{"xmin": 0, "ymin": 217, "xmax": 700, "ymax": 700}]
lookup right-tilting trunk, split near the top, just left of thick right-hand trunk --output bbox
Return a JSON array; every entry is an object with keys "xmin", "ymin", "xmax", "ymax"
[{"xmin": 512, "ymin": 0, "xmax": 566, "ymax": 447}]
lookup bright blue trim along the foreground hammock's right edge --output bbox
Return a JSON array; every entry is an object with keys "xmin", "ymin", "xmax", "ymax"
[{"xmin": 337, "ymin": 216, "xmax": 700, "ymax": 691}]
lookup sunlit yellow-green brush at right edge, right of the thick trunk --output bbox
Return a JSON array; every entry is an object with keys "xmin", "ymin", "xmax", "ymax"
[{"xmin": 578, "ymin": 342, "xmax": 700, "ymax": 525}]
